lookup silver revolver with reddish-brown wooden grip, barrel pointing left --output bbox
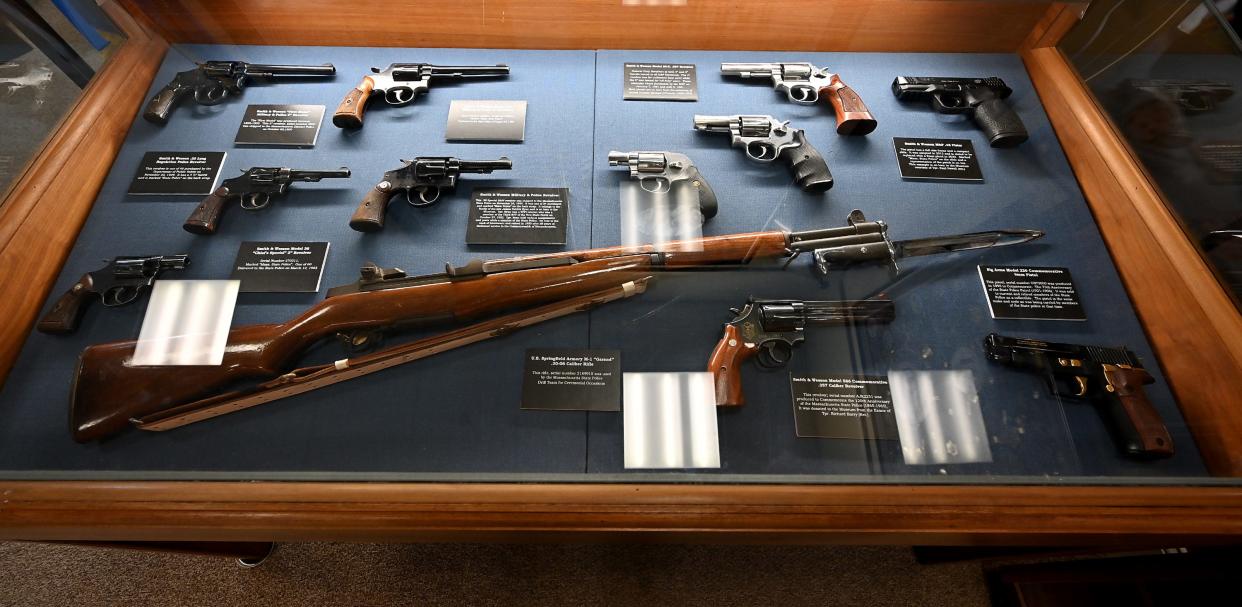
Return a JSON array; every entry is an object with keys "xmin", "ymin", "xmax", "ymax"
[{"xmin": 720, "ymin": 63, "xmax": 876, "ymax": 135}]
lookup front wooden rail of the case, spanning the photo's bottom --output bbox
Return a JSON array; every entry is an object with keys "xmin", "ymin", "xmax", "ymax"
[{"xmin": 0, "ymin": 482, "xmax": 1242, "ymax": 545}]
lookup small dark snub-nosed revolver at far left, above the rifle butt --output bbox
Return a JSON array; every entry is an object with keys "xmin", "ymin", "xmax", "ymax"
[{"xmin": 36, "ymin": 254, "xmax": 190, "ymax": 335}]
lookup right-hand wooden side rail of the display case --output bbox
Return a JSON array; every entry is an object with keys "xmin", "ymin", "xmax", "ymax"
[{"xmin": 1022, "ymin": 47, "xmax": 1242, "ymax": 477}]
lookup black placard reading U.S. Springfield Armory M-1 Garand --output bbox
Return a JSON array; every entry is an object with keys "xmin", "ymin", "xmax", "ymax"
[{"xmin": 522, "ymin": 348, "xmax": 621, "ymax": 411}]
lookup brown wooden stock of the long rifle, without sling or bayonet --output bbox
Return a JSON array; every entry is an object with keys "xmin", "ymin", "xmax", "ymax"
[{"xmin": 70, "ymin": 232, "xmax": 787, "ymax": 442}]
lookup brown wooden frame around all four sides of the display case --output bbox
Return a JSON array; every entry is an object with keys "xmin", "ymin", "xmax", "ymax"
[{"xmin": 0, "ymin": 0, "xmax": 1242, "ymax": 545}]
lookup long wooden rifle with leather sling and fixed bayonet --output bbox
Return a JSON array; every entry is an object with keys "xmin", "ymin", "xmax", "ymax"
[{"xmin": 71, "ymin": 212, "xmax": 1043, "ymax": 441}]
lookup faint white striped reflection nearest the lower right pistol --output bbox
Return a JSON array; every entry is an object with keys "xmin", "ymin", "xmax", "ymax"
[{"xmin": 888, "ymin": 370, "xmax": 992, "ymax": 465}]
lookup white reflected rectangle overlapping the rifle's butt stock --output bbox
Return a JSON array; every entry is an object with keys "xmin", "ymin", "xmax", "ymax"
[{"xmin": 129, "ymin": 281, "xmax": 241, "ymax": 366}]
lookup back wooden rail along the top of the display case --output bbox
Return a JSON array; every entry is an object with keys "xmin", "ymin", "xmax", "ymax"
[{"xmin": 118, "ymin": 0, "xmax": 1051, "ymax": 52}]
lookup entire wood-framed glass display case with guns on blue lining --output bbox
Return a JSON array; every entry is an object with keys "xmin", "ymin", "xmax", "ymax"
[{"xmin": 0, "ymin": 0, "xmax": 1242, "ymax": 542}]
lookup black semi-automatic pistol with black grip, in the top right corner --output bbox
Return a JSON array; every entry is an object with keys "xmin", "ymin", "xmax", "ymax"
[{"xmin": 893, "ymin": 76, "xmax": 1027, "ymax": 148}]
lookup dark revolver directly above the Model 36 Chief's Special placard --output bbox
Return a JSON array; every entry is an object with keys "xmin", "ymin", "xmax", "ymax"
[{"xmin": 181, "ymin": 166, "xmax": 349, "ymax": 235}]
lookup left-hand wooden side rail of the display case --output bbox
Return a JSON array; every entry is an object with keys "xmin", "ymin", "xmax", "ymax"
[{"xmin": 0, "ymin": 1, "xmax": 168, "ymax": 381}]
